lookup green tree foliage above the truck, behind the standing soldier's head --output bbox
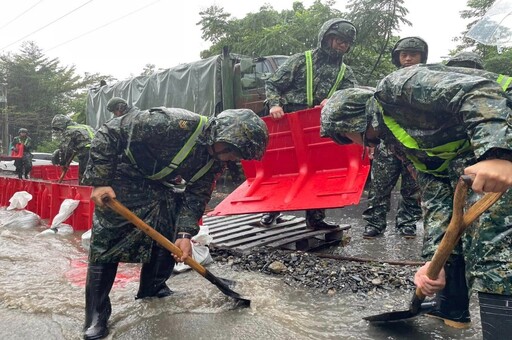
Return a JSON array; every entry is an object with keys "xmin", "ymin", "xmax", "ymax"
[{"xmin": 197, "ymin": 0, "xmax": 410, "ymax": 86}]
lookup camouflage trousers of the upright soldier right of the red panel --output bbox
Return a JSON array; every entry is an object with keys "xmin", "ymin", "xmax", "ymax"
[{"xmin": 363, "ymin": 144, "xmax": 421, "ymax": 231}]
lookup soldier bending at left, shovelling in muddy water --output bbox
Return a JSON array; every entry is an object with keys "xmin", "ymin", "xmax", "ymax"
[{"xmin": 84, "ymin": 107, "xmax": 268, "ymax": 339}]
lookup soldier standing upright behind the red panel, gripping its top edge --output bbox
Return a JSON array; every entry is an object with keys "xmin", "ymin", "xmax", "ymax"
[{"xmin": 261, "ymin": 18, "xmax": 357, "ymax": 229}]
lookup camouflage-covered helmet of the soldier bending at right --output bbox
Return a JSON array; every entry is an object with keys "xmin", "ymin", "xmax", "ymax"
[{"xmin": 320, "ymin": 87, "xmax": 375, "ymax": 144}]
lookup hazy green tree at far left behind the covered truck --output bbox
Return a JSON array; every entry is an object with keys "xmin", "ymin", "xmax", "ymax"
[{"xmin": 0, "ymin": 42, "xmax": 104, "ymax": 149}]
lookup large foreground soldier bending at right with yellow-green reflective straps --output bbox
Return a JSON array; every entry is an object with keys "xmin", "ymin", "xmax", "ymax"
[{"xmin": 322, "ymin": 65, "xmax": 512, "ymax": 339}]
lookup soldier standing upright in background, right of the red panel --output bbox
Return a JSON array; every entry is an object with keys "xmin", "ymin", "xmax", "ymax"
[{"xmin": 363, "ymin": 37, "xmax": 428, "ymax": 238}]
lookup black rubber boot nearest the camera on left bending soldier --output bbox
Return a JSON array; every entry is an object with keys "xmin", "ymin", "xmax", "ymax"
[{"xmin": 84, "ymin": 263, "xmax": 118, "ymax": 340}]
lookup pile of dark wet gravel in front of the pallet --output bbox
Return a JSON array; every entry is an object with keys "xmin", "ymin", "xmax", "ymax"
[{"xmin": 211, "ymin": 248, "xmax": 417, "ymax": 294}]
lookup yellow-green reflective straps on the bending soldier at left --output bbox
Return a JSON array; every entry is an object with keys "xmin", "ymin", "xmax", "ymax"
[{"xmin": 125, "ymin": 116, "xmax": 215, "ymax": 187}]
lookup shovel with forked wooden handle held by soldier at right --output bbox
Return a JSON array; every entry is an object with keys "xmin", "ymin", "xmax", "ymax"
[{"xmin": 363, "ymin": 175, "xmax": 503, "ymax": 323}]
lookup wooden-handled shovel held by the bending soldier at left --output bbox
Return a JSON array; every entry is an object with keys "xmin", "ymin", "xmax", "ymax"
[{"xmin": 103, "ymin": 198, "xmax": 251, "ymax": 308}]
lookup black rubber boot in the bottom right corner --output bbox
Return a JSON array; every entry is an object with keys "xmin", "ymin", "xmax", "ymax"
[{"xmin": 478, "ymin": 292, "xmax": 512, "ymax": 340}]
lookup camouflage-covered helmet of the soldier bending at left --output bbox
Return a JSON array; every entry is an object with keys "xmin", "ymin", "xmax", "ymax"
[{"xmin": 208, "ymin": 109, "xmax": 268, "ymax": 160}]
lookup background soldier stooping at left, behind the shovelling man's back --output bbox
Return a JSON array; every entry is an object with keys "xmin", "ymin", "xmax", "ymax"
[{"xmin": 52, "ymin": 114, "xmax": 94, "ymax": 184}]
